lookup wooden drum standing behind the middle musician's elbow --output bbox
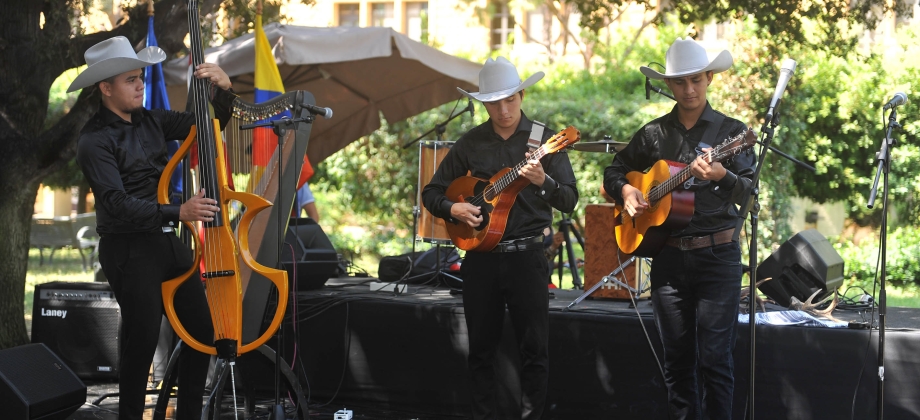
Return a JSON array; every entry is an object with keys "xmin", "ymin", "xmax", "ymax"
[{"xmin": 415, "ymin": 140, "xmax": 454, "ymax": 244}]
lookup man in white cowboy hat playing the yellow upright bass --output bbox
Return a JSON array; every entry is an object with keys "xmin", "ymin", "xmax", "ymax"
[{"xmin": 68, "ymin": 36, "xmax": 235, "ymax": 420}]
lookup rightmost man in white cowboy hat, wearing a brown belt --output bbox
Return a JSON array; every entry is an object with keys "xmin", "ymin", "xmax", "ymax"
[{"xmin": 604, "ymin": 38, "xmax": 754, "ymax": 419}]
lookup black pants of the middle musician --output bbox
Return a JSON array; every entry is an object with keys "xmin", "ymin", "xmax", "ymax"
[{"xmin": 461, "ymin": 250, "xmax": 549, "ymax": 419}]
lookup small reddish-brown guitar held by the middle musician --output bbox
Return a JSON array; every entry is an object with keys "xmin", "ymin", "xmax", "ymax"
[{"xmin": 445, "ymin": 126, "xmax": 581, "ymax": 251}]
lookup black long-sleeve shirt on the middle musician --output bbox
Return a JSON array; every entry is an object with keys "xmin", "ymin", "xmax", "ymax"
[{"xmin": 422, "ymin": 111, "xmax": 578, "ymax": 240}]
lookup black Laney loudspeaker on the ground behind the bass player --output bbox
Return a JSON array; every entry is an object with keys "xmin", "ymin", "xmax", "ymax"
[{"xmin": 32, "ymin": 282, "xmax": 121, "ymax": 379}]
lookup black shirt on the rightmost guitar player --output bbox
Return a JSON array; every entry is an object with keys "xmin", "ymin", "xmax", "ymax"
[{"xmin": 604, "ymin": 102, "xmax": 754, "ymax": 236}]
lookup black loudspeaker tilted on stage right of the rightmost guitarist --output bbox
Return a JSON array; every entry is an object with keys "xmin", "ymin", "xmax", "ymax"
[{"xmin": 757, "ymin": 229, "xmax": 843, "ymax": 307}]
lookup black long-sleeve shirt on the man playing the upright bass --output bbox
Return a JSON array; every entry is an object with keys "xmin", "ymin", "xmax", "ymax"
[{"xmin": 77, "ymin": 87, "xmax": 236, "ymax": 235}]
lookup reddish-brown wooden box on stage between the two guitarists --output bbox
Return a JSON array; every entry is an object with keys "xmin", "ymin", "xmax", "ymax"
[{"xmin": 584, "ymin": 204, "xmax": 650, "ymax": 299}]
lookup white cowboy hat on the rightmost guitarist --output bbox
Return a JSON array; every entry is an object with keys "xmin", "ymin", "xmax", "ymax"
[{"xmin": 639, "ymin": 38, "xmax": 733, "ymax": 80}]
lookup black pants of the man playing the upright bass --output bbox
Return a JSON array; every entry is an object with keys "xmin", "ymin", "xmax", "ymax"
[{"xmin": 99, "ymin": 233, "xmax": 214, "ymax": 420}]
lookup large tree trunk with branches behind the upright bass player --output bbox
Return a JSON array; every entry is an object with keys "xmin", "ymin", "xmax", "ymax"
[{"xmin": 0, "ymin": 0, "xmax": 220, "ymax": 350}]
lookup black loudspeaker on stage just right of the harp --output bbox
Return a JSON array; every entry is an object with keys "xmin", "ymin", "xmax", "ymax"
[{"xmin": 281, "ymin": 218, "xmax": 339, "ymax": 291}]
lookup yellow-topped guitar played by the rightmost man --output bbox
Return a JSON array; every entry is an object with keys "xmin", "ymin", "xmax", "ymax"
[{"xmin": 614, "ymin": 130, "xmax": 757, "ymax": 257}]
